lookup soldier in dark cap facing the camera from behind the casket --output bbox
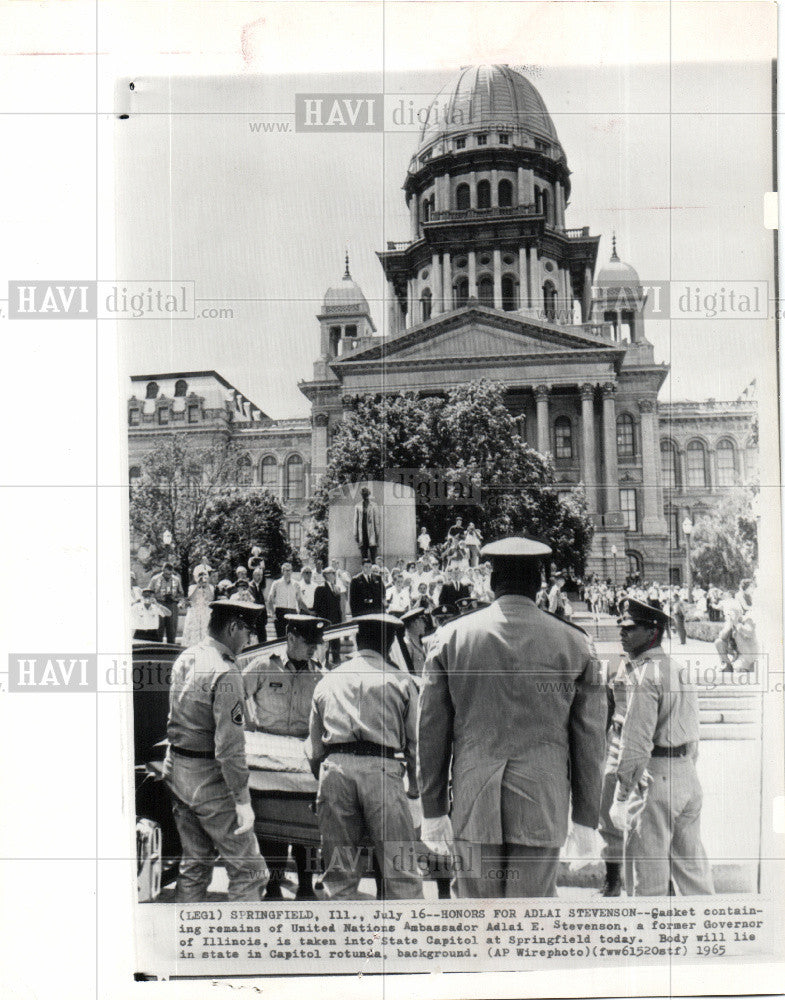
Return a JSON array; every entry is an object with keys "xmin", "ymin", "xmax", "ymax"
[{"xmin": 243, "ymin": 614, "xmax": 328, "ymax": 899}]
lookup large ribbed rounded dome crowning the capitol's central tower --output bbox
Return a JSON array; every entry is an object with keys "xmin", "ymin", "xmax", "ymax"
[{"xmin": 420, "ymin": 65, "xmax": 561, "ymax": 152}]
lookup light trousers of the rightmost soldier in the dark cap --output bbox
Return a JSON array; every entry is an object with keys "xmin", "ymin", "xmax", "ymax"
[{"xmin": 624, "ymin": 757, "xmax": 714, "ymax": 896}]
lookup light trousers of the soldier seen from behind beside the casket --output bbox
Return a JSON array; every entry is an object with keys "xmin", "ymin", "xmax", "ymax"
[{"xmin": 316, "ymin": 753, "xmax": 422, "ymax": 899}]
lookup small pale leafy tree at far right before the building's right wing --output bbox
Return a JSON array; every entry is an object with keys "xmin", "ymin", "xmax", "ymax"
[{"xmin": 690, "ymin": 488, "xmax": 758, "ymax": 590}]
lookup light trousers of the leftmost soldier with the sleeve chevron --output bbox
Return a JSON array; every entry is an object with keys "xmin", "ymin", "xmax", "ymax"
[{"xmin": 164, "ymin": 752, "xmax": 269, "ymax": 903}]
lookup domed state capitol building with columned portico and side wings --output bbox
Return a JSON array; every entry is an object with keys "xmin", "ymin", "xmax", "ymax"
[{"xmin": 128, "ymin": 66, "xmax": 757, "ymax": 582}]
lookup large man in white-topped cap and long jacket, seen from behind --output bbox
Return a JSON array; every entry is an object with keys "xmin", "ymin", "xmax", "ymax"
[{"xmin": 419, "ymin": 538, "xmax": 607, "ymax": 898}]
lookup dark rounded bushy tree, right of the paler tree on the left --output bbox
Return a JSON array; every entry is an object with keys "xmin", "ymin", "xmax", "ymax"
[{"xmin": 202, "ymin": 487, "xmax": 292, "ymax": 575}]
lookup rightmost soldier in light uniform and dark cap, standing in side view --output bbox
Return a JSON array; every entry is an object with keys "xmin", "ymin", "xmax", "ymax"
[{"xmin": 610, "ymin": 598, "xmax": 714, "ymax": 896}]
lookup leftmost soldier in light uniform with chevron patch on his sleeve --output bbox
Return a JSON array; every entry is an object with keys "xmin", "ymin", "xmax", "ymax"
[{"xmin": 164, "ymin": 600, "xmax": 268, "ymax": 903}]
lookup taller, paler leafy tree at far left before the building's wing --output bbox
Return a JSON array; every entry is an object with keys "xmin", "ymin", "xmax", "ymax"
[{"xmin": 129, "ymin": 434, "xmax": 248, "ymax": 589}]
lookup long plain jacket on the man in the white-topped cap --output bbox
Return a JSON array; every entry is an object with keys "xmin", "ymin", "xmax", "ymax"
[{"xmin": 419, "ymin": 595, "xmax": 607, "ymax": 847}]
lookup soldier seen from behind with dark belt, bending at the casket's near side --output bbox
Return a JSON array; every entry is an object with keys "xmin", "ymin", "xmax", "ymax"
[{"xmin": 308, "ymin": 614, "xmax": 422, "ymax": 899}]
